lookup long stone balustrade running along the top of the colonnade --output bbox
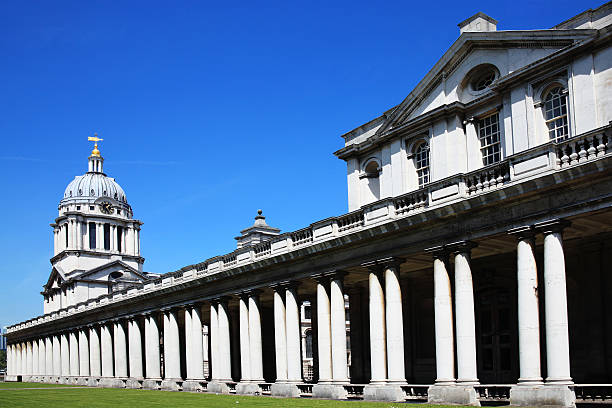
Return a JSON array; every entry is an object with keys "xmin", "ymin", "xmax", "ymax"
[{"xmin": 7, "ymin": 124, "xmax": 612, "ymax": 333}]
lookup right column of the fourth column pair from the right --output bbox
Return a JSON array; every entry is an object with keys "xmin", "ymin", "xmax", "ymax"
[{"xmin": 330, "ymin": 272, "xmax": 349, "ymax": 383}]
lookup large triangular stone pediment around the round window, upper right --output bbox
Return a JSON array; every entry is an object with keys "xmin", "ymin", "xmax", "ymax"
[{"xmin": 374, "ymin": 30, "xmax": 596, "ymax": 138}]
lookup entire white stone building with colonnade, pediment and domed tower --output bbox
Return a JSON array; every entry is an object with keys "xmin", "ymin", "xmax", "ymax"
[{"xmin": 7, "ymin": 3, "xmax": 612, "ymax": 406}]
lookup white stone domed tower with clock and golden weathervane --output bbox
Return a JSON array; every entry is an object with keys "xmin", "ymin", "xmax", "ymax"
[{"xmin": 42, "ymin": 137, "xmax": 150, "ymax": 313}]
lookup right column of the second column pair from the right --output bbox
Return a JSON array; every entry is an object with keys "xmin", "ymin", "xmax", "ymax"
[{"xmin": 453, "ymin": 242, "xmax": 478, "ymax": 384}]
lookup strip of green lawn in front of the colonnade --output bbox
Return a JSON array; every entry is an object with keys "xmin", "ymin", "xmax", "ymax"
[{"xmin": 0, "ymin": 383, "xmax": 456, "ymax": 408}]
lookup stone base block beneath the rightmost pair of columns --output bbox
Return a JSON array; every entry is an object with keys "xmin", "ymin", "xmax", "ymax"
[{"xmin": 510, "ymin": 385, "xmax": 576, "ymax": 408}]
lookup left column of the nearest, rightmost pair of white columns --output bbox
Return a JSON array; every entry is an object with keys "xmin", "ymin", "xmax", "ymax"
[{"xmin": 509, "ymin": 227, "xmax": 542, "ymax": 385}]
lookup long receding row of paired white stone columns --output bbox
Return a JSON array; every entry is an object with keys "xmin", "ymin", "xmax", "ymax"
[{"xmin": 8, "ymin": 221, "xmax": 572, "ymax": 402}]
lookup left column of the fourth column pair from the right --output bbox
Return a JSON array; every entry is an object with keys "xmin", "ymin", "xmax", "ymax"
[{"xmin": 316, "ymin": 277, "xmax": 332, "ymax": 384}]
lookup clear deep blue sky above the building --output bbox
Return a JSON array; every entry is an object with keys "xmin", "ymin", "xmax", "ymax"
[{"xmin": 0, "ymin": 0, "xmax": 602, "ymax": 327}]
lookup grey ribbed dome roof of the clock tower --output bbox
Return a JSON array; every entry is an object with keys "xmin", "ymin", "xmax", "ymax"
[{"xmin": 62, "ymin": 172, "xmax": 127, "ymax": 204}]
